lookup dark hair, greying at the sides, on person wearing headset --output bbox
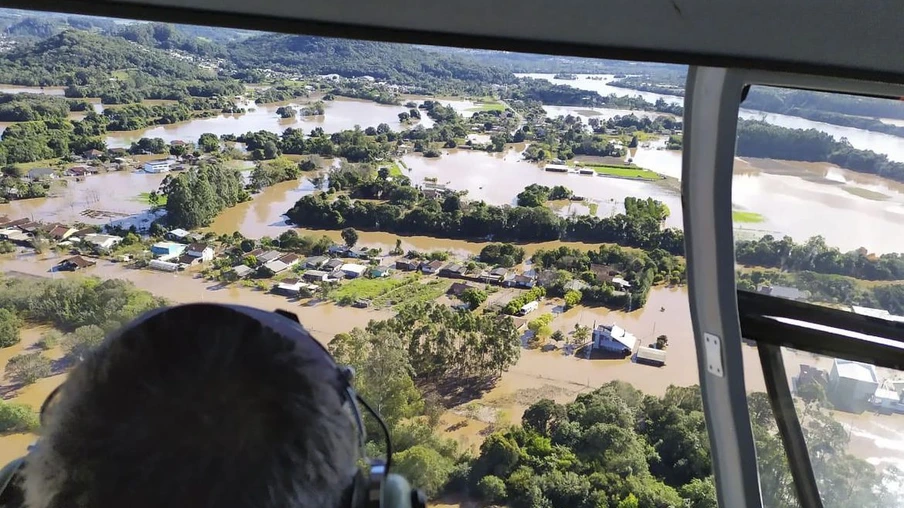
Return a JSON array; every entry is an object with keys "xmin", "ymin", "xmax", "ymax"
[{"xmin": 24, "ymin": 305, "xmax": 358, "ymax": 508}]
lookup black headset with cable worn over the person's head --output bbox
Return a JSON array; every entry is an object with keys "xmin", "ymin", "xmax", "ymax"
[{"xmin": 0, "ymin": 303, "xmax": 427, "ymax": 508}]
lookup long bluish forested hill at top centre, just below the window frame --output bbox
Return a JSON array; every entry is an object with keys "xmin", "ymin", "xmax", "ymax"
[{"xmin": 231, "ymin": 34, "xmax": 515, "ymax": 85}]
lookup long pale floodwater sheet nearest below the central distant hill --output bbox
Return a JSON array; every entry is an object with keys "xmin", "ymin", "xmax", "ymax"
[{"xmin": 107, "ymin": 97, "xmax": 433, "ymax": 148}]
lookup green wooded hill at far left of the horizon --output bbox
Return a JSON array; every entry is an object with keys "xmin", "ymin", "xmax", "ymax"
[{"xmin": 0, "ymin": 30, "xmax": 209, "ymax": 86}]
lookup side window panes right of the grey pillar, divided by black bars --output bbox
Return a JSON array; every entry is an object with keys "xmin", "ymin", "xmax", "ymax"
[{"xmin": 732, "ymin": 86, "xmax": 904, "ymax": 506}]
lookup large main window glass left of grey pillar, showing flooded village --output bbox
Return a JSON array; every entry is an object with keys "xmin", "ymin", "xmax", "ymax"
[{"xmin": 0, "ymin": 10, "xmax": 740, "ymax": 508}]
